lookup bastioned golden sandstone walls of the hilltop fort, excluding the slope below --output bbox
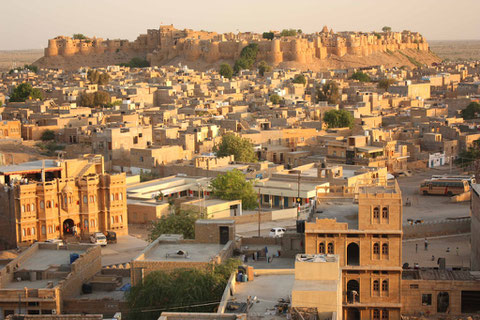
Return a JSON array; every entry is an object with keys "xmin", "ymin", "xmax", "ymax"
[{"xmin": 40, "ymin": 25, "xmax": 429, "ymax": 65}]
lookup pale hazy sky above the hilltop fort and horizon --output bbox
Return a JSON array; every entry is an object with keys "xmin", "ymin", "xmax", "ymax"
[{"xmin": 0, "ymin": 0, "xmax": 480, "ymax": 50}]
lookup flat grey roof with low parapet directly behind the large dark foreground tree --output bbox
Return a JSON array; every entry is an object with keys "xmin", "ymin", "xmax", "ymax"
[{"xmin": 144, "ymin": 242, "xmax": 224, "ymax": 262}]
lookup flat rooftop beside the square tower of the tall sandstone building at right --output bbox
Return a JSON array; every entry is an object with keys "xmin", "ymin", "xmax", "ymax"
[{"xmin": 313, "ymin": 201, "xmax": 358, "ymax": 230}]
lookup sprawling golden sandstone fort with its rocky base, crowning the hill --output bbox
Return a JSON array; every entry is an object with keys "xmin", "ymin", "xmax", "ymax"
[{"xmin": 32, "ymin": 25, "xmax": 436, "ymax": 69}]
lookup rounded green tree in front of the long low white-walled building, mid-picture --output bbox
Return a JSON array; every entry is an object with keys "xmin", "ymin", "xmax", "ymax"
[{"xmin": 211, "ymin": 169, "xmax": 257, "ymax": 210}]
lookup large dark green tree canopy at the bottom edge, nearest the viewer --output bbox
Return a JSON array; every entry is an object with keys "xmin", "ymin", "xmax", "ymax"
[{"xmin": 126, "ymin": 259, "xmax": 241, "ymax": 320}]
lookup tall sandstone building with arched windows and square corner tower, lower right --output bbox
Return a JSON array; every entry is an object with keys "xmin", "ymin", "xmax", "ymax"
[{"xmin": 305, "ymin": 182, "xmax": 402, "ymax": 320}]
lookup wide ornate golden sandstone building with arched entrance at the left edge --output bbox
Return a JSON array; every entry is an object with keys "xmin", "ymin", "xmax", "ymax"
[{"xmin": 0, "ymin": 156, "xmax": 128, "ymax": 248}]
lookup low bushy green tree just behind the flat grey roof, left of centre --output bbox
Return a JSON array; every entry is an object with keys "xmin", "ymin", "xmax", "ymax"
[{"xmin": 149, "ymin": 209, "xmax": 200, "ymax": 241}]
